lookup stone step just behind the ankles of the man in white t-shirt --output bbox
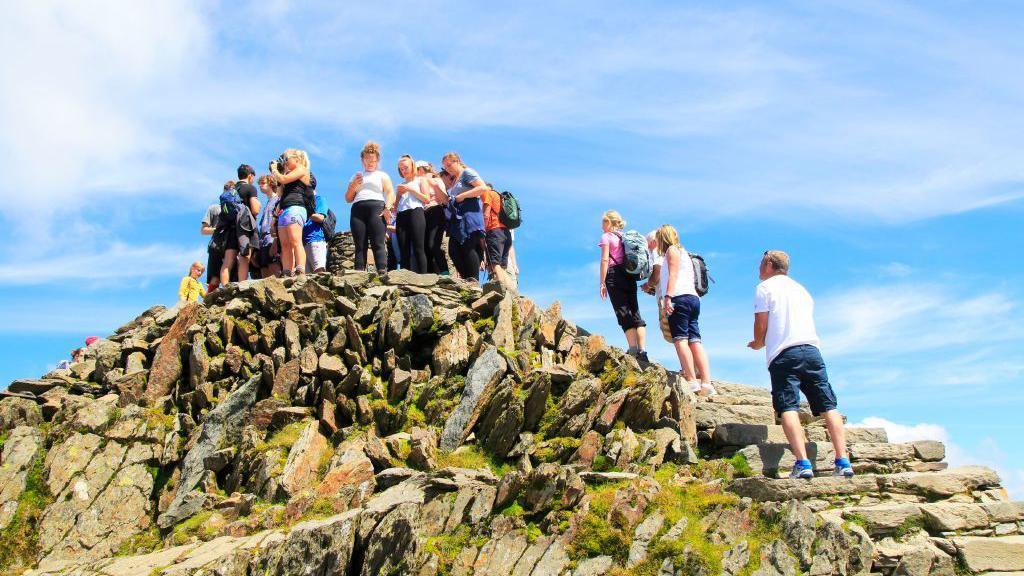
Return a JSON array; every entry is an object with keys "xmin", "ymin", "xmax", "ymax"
[{"xmin": 737, "ymin": 441, "xmax": 946, "ymax": 477}]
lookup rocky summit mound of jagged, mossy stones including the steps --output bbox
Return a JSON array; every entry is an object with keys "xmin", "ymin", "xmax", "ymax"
[{"xmin": 0, "ymin": 253, "xmax": 1024, "ymax": 576}]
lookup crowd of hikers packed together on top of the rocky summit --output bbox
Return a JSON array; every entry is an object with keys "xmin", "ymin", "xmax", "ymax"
[{"xmin": 178, "ymin": 141, "xmax": 520, "ymax": 301}]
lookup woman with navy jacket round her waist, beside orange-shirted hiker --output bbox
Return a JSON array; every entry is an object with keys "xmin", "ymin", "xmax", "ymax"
[{"xmin": 441, "ymin": 152, "xmax": 487, "ymax": 283}]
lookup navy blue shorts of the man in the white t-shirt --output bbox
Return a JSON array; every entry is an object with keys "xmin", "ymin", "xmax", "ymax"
[{"xmin": 768, "ymin": 344, "xmax": 837, "ymax": 416}]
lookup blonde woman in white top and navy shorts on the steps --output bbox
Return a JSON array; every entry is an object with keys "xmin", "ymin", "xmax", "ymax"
[{"xmin": 654, "ymin": 224, "xmax": 718, "ymax": 396}]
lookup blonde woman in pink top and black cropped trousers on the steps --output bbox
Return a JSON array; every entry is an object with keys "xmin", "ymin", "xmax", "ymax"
[{"xmin": 597, "ymin": 210, "xmax": 647, "ymax": 362}]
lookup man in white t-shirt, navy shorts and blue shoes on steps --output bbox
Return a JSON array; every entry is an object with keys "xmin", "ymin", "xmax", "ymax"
[{"xmin": 746, "ymin": 250, "xmax": 853, "ymax": 479}]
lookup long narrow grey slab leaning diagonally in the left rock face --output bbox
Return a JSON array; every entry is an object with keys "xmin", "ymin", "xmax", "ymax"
[{"xmin": 157, "ymin": 376, "xmax": 259, "ymax": 529}]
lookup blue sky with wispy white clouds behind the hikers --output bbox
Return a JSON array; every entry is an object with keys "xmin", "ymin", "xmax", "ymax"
[{"xmin": 0, "ymin": 1, "xmax": 1024, "ymax": 496}]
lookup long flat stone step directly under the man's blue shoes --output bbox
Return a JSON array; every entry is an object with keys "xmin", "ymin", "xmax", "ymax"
[{"xmin": 729, "ymin": 466, "xmax": 1006, "ymax": 502}]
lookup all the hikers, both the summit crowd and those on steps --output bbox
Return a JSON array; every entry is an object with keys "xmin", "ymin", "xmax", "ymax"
[{"xmin": 179, "ymin": 141, "xmax": 854, "ymax": 479}]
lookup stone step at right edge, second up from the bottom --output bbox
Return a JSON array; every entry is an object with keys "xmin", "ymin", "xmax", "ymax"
[{"xmin": 840, "ymin": 502, "xmax": 1024, "ymax": 537}]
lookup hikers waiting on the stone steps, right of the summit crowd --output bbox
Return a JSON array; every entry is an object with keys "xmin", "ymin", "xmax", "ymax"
[{"xmin": 598, "ymin": 210, "xmax": 854, "ymax": 479}]
